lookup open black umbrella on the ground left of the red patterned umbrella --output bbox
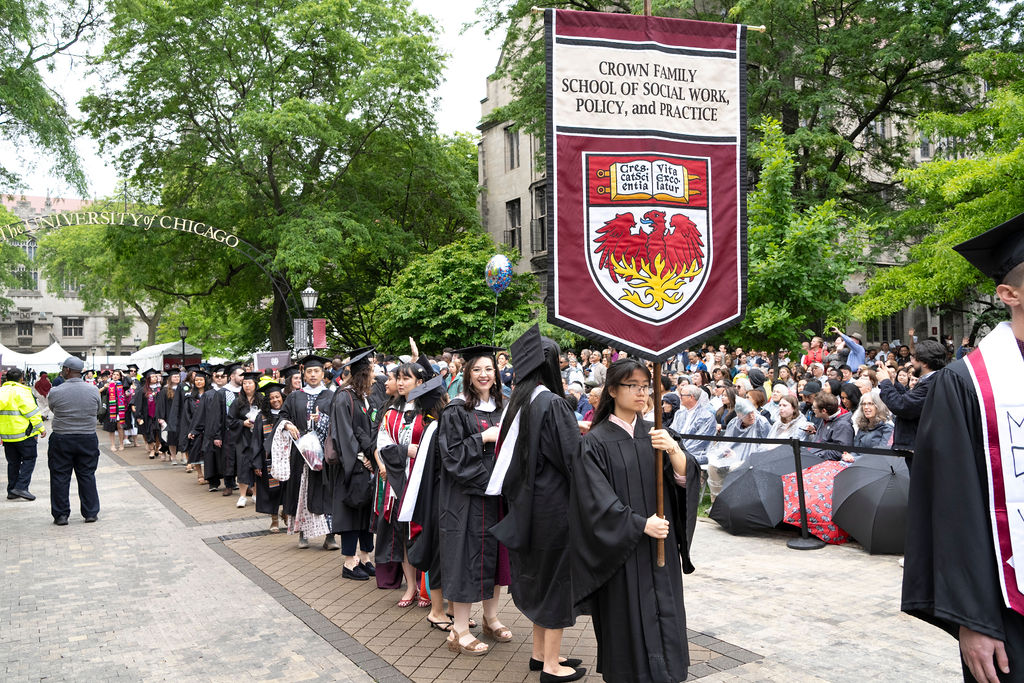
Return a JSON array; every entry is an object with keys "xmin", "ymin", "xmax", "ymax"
[{"xmin": 708, "ymin": 466, "xmax": 792, "ymax": 536}]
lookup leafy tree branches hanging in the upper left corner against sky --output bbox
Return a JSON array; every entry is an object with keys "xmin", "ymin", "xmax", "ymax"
[{"xmin": 0, "ymin": 0, "xmax": 99, "ymax": 193}]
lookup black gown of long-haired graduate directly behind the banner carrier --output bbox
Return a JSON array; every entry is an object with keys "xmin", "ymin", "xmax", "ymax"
[{"xmin": 492, "ymin": 391, "xmax": 580, "ymax": 629}]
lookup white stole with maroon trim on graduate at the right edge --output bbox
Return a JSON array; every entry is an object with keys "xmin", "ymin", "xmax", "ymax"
[{"xmin": 967, "ymin": 323, "xmax": 1024, "ymax": 614}]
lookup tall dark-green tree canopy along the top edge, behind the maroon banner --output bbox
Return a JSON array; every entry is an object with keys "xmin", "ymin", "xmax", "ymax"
[{"xmin": 479, "ymin": 0, "xmax": 1024, "ymax": 214}]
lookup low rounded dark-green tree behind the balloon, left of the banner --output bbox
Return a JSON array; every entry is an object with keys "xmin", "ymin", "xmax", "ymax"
[{"xmin": 373, "ymin": 233, "xmax": 541, "ymax": 352}]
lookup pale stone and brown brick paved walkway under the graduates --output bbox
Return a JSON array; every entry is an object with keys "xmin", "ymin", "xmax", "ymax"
[{"xmin": 0, "ymin": 434, "xmax": 959, "ymax": 681}]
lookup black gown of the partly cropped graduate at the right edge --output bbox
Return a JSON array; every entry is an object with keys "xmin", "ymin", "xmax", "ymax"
[{"xmin": 901, "ymin": 360, "xmax": 1024, "ymax": 681}]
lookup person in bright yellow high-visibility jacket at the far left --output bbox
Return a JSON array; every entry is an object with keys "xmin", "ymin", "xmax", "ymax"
[{"xmin": 0, "ymin": 368, "xmax": 46, "ymax": 501}]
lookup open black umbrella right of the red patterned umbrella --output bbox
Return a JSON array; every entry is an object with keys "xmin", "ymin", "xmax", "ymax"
[{"xmin": 833, "ymin": 456, "xmax": 910, "ymax": 555}]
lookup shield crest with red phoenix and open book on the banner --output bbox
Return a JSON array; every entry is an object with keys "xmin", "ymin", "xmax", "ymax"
[{"xmin": 584, "ymin": 154, "xmax": 712, "ymax": 324}]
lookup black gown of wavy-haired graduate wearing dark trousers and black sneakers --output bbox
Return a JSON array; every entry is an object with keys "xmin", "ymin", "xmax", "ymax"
[{"xmin": 324, "ymin": 389, "xmax": 377, "ymax": 532}]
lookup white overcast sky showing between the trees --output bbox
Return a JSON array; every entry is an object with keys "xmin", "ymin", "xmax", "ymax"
[{"xmin": 6, "ymin": 0, "xmax": 501, "ymax": 197}]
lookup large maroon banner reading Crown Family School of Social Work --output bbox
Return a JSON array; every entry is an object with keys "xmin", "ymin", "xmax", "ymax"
[{"xmin": 545, "ymin": 9, "xmax": 746, "ymax": 359}]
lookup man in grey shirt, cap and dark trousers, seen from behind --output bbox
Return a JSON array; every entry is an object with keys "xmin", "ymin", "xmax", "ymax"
[{"xmin": 46, "ymin": 355, "xmax": 102, "ymax": 526}]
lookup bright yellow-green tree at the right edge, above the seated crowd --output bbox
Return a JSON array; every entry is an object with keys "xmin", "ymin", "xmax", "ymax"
[{"xmin": 852, "ymin": 52, "xmax": 1024, "ymax": 337}]
